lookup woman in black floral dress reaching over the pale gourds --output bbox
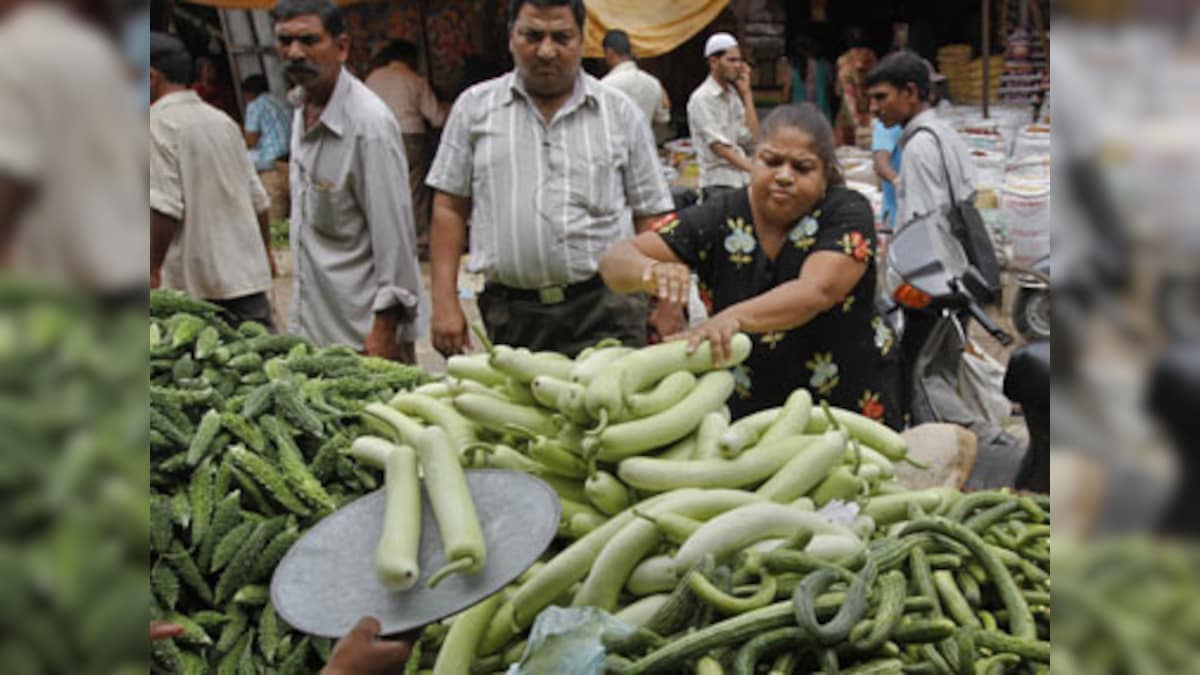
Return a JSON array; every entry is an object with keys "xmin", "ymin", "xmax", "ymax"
[{"xmin": 600, "ymin": 104, "xmax": 901, "ymax": 428}]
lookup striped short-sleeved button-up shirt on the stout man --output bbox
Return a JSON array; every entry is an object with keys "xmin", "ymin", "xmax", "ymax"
[{"xmin": 426, "ymin": 72, "xmax": 673, "ymax": 288}]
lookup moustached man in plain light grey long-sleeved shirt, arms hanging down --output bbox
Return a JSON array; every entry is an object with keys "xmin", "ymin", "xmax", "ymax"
[{"xmin": 272, "ymin": 0, "xmax": 421, "ymax": 363}]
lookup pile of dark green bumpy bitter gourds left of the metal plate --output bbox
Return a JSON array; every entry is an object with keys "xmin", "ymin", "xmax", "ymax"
[{"xmin": 142, "ymin": 291, "xmax": 431, "ymax": 674}]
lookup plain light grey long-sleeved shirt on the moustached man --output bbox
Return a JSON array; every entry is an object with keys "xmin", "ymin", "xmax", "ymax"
[{"xmin": 288, "ymin": 70, "xmax": 421, "ymax": 350}]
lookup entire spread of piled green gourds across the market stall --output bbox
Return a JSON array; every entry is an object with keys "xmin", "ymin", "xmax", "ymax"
[{"xmin": 150, "ymin": 292, "xmax": 1050, "ymax": 674}]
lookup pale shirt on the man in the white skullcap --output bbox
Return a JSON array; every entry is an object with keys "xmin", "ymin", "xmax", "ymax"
[{"xmin": 688, "ymin": 76, "xmax": 754, "ymax": 187}]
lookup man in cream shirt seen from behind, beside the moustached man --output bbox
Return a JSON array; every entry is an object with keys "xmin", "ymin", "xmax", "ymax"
[{"xmin": 150, "ymin": 32, "xmax": 272, "ymax": 327}]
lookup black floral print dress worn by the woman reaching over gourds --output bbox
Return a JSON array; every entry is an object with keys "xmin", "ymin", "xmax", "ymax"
[{"xmin": 654, "ymin": 186, "xmax": 901, "ymax": 428}]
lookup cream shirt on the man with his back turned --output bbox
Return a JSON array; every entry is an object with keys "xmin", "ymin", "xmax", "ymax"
[{"xmin": 150, "ymin": 90, "xmax": 271, "ymax": 300}]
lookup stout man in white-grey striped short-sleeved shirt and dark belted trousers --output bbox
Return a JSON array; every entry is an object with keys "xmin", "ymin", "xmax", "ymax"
[{"xmin": 426, "ymin": 0, "xmax": 672, "ymax": 356}]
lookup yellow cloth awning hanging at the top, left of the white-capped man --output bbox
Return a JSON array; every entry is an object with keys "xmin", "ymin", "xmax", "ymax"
[{"xmin": 583, "ymin": 0, "xmax": 730, "ymax": 58}]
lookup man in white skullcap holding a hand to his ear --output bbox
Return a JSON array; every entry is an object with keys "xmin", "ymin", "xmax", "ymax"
[{"xmin": 688, "ymin": 32, "xmax": 758, "ymax": 199}]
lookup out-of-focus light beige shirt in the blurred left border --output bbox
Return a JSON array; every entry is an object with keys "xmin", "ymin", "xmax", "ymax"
[{"xmin": 0, "ymin": 2, "xmax": 150, "ymax": 292}]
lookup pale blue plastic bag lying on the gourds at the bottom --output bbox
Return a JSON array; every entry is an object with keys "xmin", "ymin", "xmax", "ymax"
[{"xmin": 508, "ymin": 607, "xmax": 634, "ymax": 675}]
